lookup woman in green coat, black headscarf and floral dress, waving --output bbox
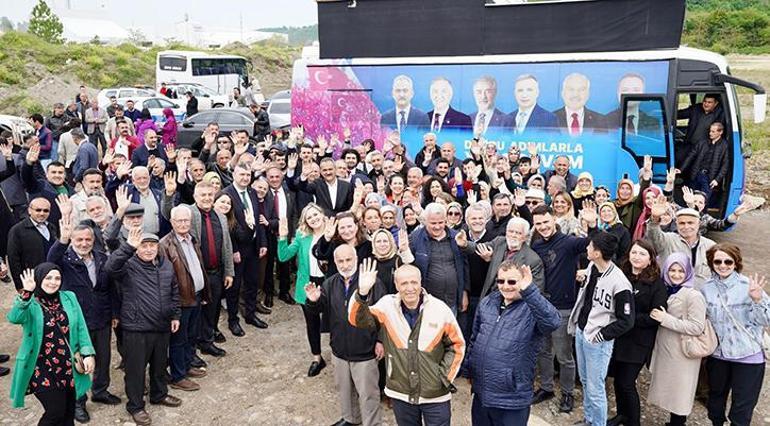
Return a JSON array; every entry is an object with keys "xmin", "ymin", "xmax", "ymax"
[{"xmin": 8, "ymin": 262, "xmax": 95, "ymax": 425}]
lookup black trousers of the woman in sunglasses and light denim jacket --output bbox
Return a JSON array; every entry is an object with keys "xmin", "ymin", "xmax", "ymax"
[{"xmin": 706, "ymin": 357, "xmax": 765, "ymax": 426}]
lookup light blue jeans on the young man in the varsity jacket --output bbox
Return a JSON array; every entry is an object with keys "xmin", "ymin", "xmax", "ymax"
[{"xmin": 575, "ymin": 329, "xmax": 614, "ymax": 426}]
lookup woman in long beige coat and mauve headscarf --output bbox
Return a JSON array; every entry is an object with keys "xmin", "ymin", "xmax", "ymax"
[{"xmin": 647, "ymin": 253, "xmax": 706, "ymax": 426}]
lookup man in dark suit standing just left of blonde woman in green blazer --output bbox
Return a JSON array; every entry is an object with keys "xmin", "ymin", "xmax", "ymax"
[{"xmin": 264, "ymin": 166, "xmax": 299, "ymax": 308}]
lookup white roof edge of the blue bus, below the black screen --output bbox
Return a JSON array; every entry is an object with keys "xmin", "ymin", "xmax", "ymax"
[{"xmin": 300, "ymin": 46, "xmax": 727, "ymax": 72}]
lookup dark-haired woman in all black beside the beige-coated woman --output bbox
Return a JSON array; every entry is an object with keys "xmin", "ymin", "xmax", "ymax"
[{"xmin": 607, "ymin": 240, "xmax": 668, "ymax": 426}]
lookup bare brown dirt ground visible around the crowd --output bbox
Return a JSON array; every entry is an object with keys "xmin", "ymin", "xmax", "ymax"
[{"xmin": 0, "ymin": 211, "xmax": 770, "ymax": 426}]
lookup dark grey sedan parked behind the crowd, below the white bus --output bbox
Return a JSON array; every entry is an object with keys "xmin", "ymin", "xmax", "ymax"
[{"xmin": 176, "ymin": 108, "xmax": 255, "ymax": 148}]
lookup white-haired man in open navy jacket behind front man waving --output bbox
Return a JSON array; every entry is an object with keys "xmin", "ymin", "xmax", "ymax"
[{"xmin": 409, "ymin": 203, "xmax": 470, "ymax": 314}]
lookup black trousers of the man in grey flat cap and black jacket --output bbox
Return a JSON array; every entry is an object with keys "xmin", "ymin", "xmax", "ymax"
[{"xmin": 123, "ymin": 330, "xmax": 170, "ymax": 414}]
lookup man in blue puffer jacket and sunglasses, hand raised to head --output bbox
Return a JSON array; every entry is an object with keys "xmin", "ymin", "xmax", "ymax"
[{"xmin": 464, "ymin": 260, "xmax": 561, "ymax": 426}]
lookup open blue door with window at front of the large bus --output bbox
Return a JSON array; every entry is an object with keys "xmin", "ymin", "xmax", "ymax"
[{"xmin": 620, "ymin": 94, "xmax": 673, "ymax": 185}]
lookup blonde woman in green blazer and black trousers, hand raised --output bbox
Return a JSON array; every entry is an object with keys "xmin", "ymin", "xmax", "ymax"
[{"xmin": 278, "ymin": 203, "xmax": 327, "ymax": 377}]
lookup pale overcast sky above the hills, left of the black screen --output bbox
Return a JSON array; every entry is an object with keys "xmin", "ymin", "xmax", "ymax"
[{"xmin": 0, "ymin": 0, "xmax": 318, "ymax": 33}]
